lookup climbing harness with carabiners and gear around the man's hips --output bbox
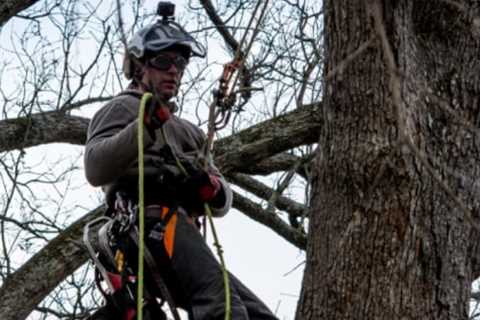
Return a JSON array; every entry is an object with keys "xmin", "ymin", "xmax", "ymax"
[{"xmin": 83, "ymin": 192, "xmax": 180, "ymax": 320}]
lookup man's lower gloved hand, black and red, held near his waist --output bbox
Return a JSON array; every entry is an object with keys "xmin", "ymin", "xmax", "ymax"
[{"xmin": 183, "ymin": 170, "xmax": 225, "ymax": 208}]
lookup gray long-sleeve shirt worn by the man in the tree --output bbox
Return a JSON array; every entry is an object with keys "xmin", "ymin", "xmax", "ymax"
[{"xmin": 84, "ymin": 90, "xmax": 232, "ymax": 216}]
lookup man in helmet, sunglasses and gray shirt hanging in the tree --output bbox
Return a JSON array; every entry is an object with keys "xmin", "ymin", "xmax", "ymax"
[{"xmin": 85, "ymin": 4, "xmax": 277, "ymax": 320}]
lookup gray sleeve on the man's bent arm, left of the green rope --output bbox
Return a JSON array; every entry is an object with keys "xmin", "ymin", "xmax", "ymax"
[{"xmin": 84, "ymin": 100, "xmax": 154, "ymax": 186}]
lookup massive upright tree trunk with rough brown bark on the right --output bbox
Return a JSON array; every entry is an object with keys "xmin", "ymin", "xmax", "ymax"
[{"xmin": 297, "ymin": 0, "xmax": 480, "ymax": 320}]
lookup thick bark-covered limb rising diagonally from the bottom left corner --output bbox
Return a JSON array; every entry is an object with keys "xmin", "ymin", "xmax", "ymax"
[{"xmin": 0, "ymin": 207, "xmax": 104, "ymax": 320}]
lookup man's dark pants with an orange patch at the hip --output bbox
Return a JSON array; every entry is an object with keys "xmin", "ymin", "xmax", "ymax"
[{"xmin": 147, "ymin": 210, "xmax": 277, "ymax": 320}]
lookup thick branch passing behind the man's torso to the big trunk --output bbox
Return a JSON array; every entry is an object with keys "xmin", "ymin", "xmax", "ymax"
[{"xmin": 0, "ymin": 103, "xmax": 321, "ymax": 172}]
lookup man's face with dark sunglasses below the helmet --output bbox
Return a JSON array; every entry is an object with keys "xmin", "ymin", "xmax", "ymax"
[{"xmin": 142, "ymin": 50, "xmax": 187, "ymax": 101}]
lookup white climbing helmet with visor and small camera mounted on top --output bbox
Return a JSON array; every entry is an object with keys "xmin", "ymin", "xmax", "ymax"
[{"xmin": 123, "ymin": 1, "xmax": 206, "ymax": 79}]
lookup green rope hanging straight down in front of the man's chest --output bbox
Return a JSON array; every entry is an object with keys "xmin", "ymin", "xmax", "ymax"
[{"xmin": 137, "ymin": 92, "xmax": 152, "ymax": 320}]
